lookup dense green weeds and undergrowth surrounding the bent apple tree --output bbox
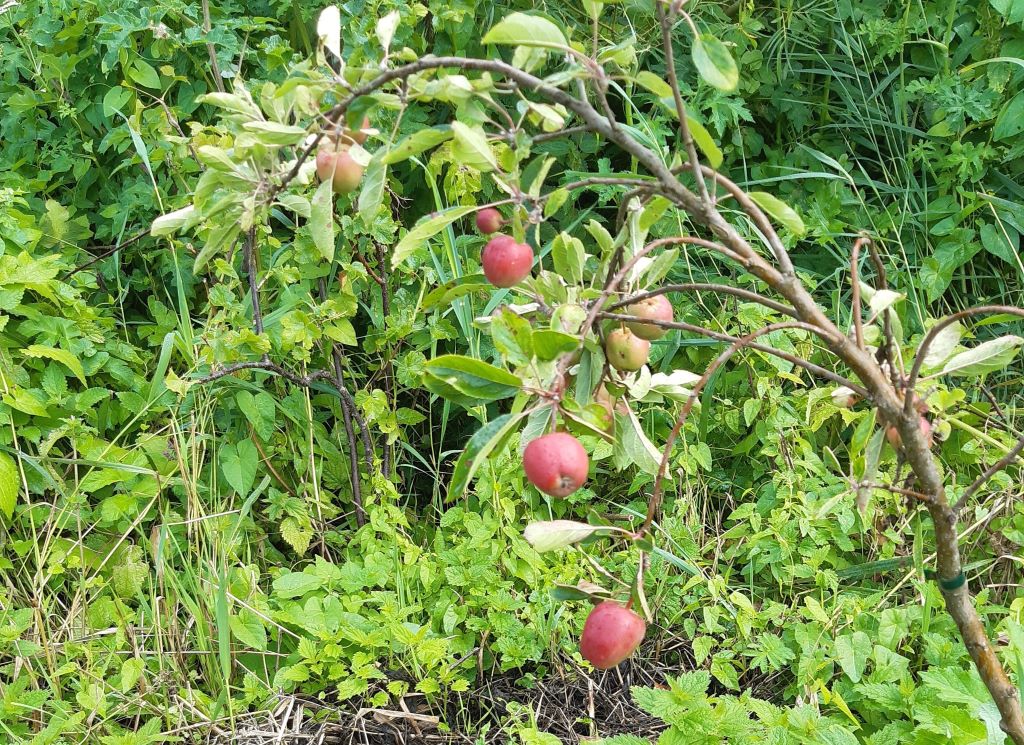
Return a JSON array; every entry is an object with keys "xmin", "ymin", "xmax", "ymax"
[{"xmin": 0, "ymin": 0, "xmax": 1024, "ymax": 745}]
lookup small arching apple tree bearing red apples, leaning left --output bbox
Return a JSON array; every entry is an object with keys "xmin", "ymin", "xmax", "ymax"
[{"xmin": 153, "ymin": 0, "xmax": 1024, "ymax": 745}]
